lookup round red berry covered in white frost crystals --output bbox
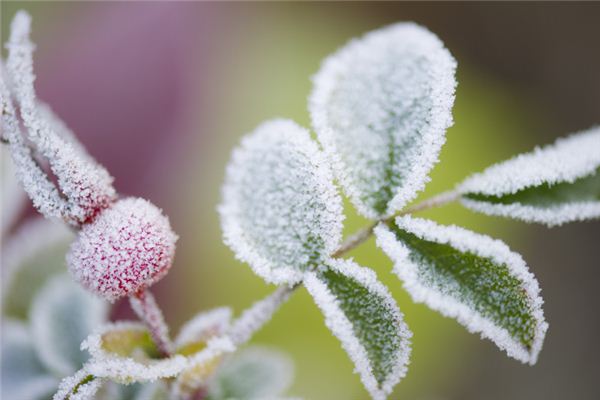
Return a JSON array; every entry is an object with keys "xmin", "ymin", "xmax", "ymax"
[{"xmin": 67, "ymin": 198, "xmax": 177, "ymax": 302}]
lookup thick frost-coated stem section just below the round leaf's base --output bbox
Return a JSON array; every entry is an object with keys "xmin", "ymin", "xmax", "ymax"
[{"xmin": 229, "ymin": 284, "xmax": 300, "ymax": 345}]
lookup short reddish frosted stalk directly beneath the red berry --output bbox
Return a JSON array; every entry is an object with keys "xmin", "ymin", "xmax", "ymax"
[{"xmin": 129, "ymin": 289, "xmax": 173, "ymax": 357}]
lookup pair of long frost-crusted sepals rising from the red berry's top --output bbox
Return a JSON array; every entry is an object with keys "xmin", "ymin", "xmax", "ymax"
[{"xmin": 2, "ymin": 11, "xmax": 116, "ymax": 226}]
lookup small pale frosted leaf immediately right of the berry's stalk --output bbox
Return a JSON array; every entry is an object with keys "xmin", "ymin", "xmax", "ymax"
[{"xmin": 175, "ymin": 307, "xmax": 231, "ymax": 353}]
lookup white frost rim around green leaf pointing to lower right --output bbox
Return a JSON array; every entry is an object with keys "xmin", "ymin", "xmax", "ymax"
[{"xmin": 374, "ymin": 216, "xmax": 548, "ymax": 365}]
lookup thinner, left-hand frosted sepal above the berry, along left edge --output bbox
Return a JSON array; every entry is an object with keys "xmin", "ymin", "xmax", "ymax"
[{"xmin": 0, "ymin": 59, "xmax": 68, "ymax": 222}]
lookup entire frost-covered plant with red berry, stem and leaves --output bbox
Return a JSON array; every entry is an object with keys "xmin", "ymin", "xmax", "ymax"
[{"xmin": 0, "ymin": 8, "xmax": 600, "ymax": 400}]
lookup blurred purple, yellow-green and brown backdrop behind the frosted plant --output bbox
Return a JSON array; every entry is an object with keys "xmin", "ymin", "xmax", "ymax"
[{"xmin": 1, "ymin": 1, "xmax": 600, "ymax": 400}]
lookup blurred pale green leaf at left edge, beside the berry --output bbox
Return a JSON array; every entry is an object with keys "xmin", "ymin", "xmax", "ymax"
[{"xmin": 0, "ymin": 217, "xmax": 74, "ymax": 319}]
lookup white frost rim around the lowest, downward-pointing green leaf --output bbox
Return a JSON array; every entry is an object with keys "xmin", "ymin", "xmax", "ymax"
[{"xmin": 304, "ymin": 259, "xmax": 412, "ymax": 400}]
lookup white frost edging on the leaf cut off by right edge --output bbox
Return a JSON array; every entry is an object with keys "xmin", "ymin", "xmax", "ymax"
[{"xmin": 458, "ymin": 127, "xmax": 600, "ymax": 226}]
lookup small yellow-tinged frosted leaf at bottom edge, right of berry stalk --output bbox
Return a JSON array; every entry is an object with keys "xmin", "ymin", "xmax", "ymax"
[{"xmin": 171, "ymin": 337, "xmax": 235, "ymax": 399}]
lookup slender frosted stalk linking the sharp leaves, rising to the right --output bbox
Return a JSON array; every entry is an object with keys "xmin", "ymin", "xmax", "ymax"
[{"xmin": 229, "ymin": 191, "xmax": 460, "ymax": 345}]
